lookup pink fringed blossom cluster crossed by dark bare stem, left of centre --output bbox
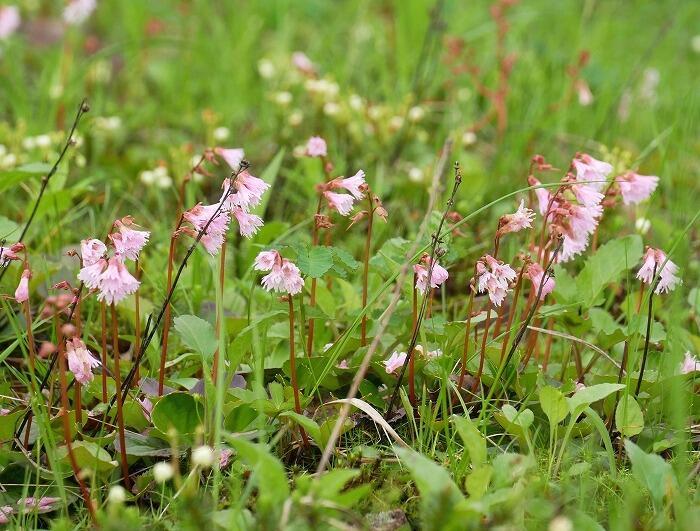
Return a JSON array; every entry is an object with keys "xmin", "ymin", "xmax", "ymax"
[{"xmin": 181, "ymin": 147, "xmax": 270, "ymax": 255}]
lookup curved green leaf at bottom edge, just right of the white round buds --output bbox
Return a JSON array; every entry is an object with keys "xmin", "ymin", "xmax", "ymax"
[{"xmin": 229, "ymin": 437, "xmax": 289, "ymax": 523}]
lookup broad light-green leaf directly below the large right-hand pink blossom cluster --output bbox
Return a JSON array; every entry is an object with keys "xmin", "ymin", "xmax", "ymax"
[{"xmin": 576, "ymin": 234, "xmax": 642, "ymax": 307}]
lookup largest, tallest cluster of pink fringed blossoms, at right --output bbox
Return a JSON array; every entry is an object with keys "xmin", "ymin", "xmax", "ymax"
[{"xmin": 528, "ymin": 153, "xmax": 659, "ymax": 262}]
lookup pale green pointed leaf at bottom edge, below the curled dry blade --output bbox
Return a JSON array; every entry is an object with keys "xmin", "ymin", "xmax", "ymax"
[{"xmin": 394, "ymin": 447, "xmax": 464, "ymax": 530}]
